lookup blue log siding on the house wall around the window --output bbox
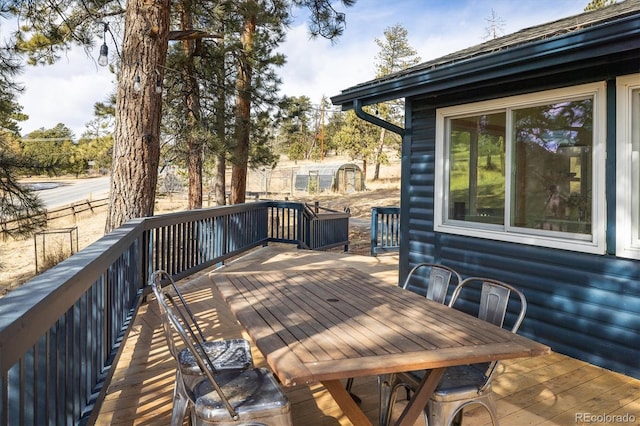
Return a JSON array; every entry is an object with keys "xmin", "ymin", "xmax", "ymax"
[{"xmin": 400, "ymin": 100, "xmax": 640, "ymax": 378}]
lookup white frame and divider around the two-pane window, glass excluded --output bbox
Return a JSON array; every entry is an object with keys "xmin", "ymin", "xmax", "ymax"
[{"xmin": 434, "ymin": 82, "xmax": 606, "ymax": 254}]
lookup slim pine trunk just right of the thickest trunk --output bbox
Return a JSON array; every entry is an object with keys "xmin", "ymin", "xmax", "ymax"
[{"xmin": 180, "ymin": 0, "xmax": 202, "ymax": 209}]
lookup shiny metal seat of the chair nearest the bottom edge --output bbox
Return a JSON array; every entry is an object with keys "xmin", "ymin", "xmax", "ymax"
[{"xmin": 192, "ymin": 368, "xmax": 291, "ymax": 426}]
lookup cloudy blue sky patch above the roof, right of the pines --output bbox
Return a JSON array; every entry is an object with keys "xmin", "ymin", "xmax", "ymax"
[{"xmin": 281, "ymin": 0, "xmax": 586, "ymax": 103}]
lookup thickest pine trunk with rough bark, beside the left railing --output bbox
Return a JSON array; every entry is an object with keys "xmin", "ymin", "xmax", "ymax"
[{"xmin": 105, "ymin": 0, "xmax": 170, "ymax": 232}]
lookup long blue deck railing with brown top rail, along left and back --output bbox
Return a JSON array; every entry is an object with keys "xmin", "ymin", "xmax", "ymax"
[{"xmin": 0, "ymin": 201, "xmax": 349, "ymax": 426}]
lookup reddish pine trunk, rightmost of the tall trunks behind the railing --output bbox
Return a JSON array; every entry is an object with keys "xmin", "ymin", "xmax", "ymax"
[{"xmin": 230, "ymin": 0, "xmax": 257, "ymax": 204}]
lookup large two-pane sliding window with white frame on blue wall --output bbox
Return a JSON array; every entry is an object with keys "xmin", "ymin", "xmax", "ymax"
[{"xmin": 435, "ymin": 84, "xmax": 605, "ymax": 253}]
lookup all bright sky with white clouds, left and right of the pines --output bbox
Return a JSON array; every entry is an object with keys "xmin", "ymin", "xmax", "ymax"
[{"xmin": 12, "ymin": 0, "xmax": 589, "ymax": 138}]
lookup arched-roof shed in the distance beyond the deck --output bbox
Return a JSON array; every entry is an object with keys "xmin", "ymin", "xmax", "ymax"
[{"xmin": 295, "ymin": 163, "xmax": 364, "ymax": 193}]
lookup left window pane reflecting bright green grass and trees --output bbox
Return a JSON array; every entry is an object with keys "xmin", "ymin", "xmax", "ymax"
[{"xmin": 449, "ymin": 112, "xmax": 506, "ymax": 225}]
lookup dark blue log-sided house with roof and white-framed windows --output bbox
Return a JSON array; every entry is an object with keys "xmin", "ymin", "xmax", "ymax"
[{"xmin": 332, "ymin": 0, "xmax": 640, "ymax": 378}]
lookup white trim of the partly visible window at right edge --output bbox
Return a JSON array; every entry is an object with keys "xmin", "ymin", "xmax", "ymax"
[{"xmin": 616, "ymin": 74, "xmax": 640, "ymax": 259}]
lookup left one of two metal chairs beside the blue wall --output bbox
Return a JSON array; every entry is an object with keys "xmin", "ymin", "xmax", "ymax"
[{"xmin": 378, "ymin": 262, "xmax": 462, "ymax": 424}]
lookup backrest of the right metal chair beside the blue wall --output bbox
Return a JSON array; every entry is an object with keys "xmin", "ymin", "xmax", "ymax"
[{"xmin": 449, "ymin": 277, "xmax": 527, "ymax": 390}]
